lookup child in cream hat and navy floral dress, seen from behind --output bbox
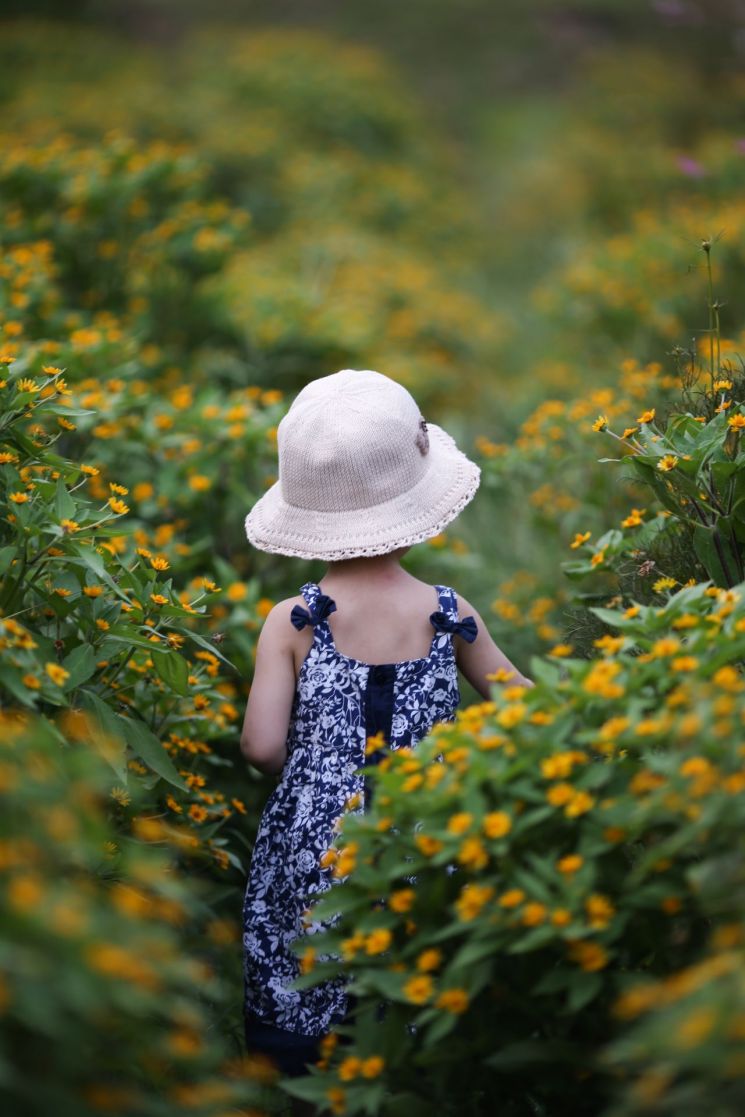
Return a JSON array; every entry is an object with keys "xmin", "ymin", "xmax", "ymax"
[{"xmin": 240, "ymin": 369, "xmax": 533, "ymax": 1075}]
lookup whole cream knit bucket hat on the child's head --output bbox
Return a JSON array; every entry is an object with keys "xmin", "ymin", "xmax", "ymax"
[{"xmin": 246, "ymin": 369, "xmax": 480, "ymax": 562}]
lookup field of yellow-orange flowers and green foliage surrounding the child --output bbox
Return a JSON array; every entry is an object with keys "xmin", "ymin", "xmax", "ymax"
[{"xmin": 0, "ymin": 20, "xmax": 745, "ymax": 1117}]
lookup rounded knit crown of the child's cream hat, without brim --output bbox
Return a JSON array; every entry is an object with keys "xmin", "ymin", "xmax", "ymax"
[{"xmin": 277, "ymin": 369, "xmax": 428, "ymax": 513}]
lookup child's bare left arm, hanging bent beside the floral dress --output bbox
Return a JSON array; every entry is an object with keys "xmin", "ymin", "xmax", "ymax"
[{"xmin": 240, "ymin": 601, "xmax": 295, "ymax": 775}]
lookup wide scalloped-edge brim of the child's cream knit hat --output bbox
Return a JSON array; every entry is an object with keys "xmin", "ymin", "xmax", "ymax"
[{"xmin": 245, "ymin": 421, "xmax": 481, "ymax": 562}]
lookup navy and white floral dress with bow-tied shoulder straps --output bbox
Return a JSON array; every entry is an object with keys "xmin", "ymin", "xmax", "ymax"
[{"xmin": 243, "ymin": 582, "xmax": 477, "ymax": 1072}]
